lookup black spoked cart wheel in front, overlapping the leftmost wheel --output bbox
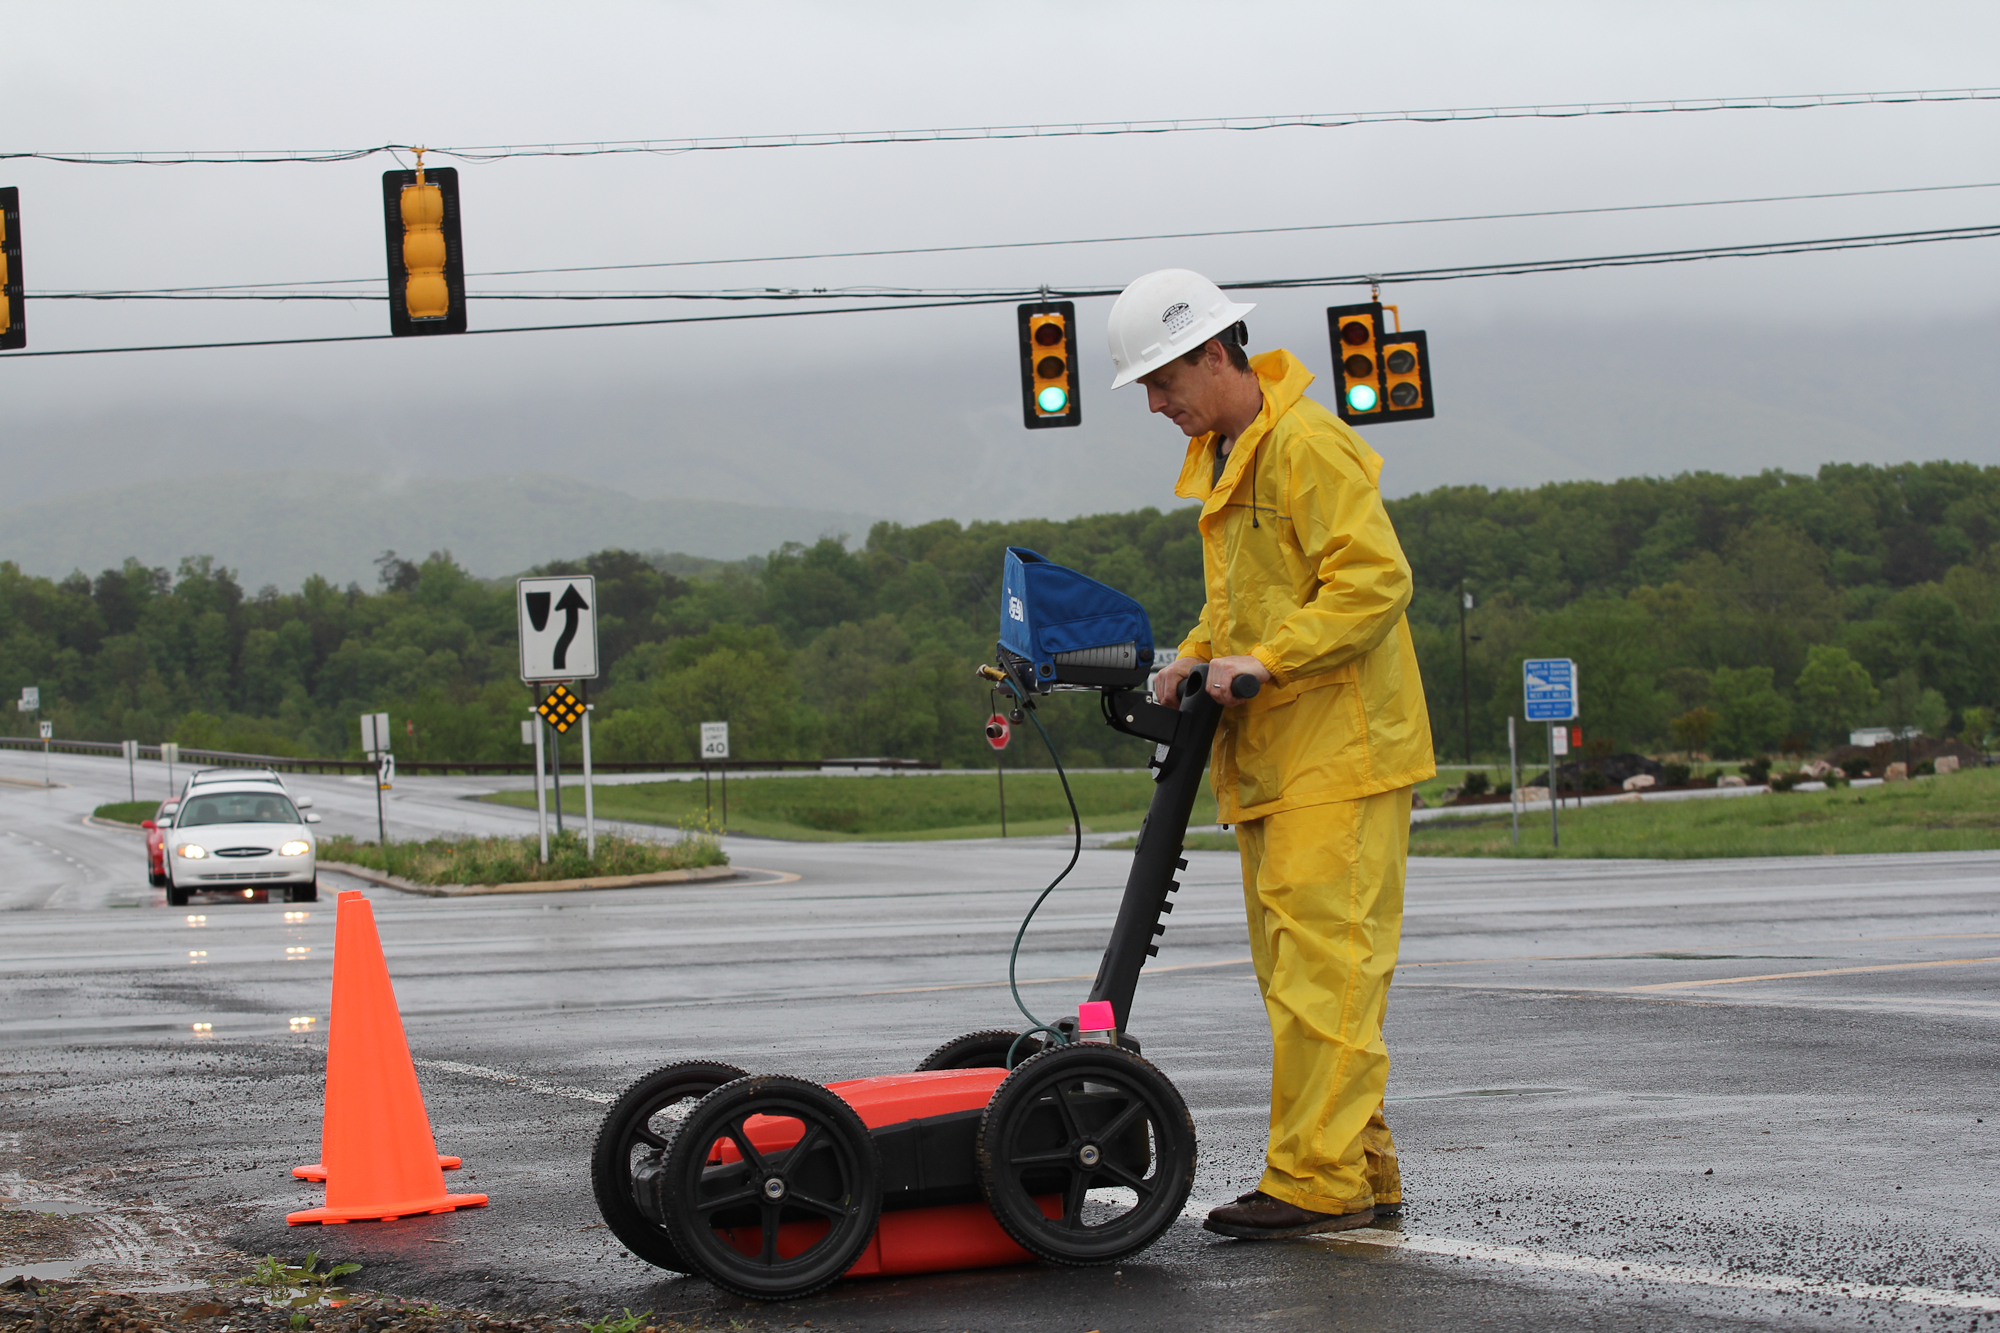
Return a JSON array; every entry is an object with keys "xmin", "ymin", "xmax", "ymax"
[{"xmin": 662, "ymin": 1075, "xmax": 882, "ymax": 1301}]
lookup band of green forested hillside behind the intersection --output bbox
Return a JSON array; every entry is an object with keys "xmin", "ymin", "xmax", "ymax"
[{"xmin": 0, "ymin": 462, "xmax": 2000, "ymax": 765}]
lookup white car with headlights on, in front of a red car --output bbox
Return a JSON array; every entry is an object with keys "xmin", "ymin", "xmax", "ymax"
[{"xmin": 166, "ymin": 779, "xmax": 320, "ymax": 907}]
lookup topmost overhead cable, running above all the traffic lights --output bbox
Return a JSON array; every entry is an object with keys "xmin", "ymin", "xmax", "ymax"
[{"xmin": 0, "ymin": 88, "xmax": 2000, "ymax": 166}]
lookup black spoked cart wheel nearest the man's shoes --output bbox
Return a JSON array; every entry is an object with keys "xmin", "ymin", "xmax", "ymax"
[{"xmin": 978, "ymin": 1041, "xmax": 1194, "ymax": 1265}]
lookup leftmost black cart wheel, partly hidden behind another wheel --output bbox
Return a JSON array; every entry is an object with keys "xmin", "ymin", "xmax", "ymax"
[{"xmin": 590, "ymin": 1061, "xmax": 746, "ymax": 1273}]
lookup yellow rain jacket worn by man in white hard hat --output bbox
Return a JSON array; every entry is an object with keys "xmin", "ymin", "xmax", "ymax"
[{"xmin": 1174, "ymin": 348, "xmax": 1438, "ymax": 825}]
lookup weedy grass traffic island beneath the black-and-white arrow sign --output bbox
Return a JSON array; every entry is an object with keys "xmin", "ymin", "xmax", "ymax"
[{"xmin": 320, "ymin": 831, "xmax": 728, "ymax": 885}]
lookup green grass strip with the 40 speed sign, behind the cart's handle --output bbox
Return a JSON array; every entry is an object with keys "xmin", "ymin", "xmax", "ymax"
[{"xmin": 484, "ymin": 771, "xmax": 1216, "ymax": 843}]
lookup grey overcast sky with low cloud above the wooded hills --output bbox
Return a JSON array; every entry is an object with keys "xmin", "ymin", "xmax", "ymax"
[{"xmin": 0, "ymin": 0, "xmax": 2000, "ymax": 556}]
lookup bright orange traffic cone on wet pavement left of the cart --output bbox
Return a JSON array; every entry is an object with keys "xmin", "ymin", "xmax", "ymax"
[{"xmin": 284, "ymin": 893, "xmax": 486, "ymax": 1227}]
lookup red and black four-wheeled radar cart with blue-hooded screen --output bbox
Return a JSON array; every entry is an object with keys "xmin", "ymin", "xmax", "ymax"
[{"xmin": 590, "ymin": 546, "xmax": 1258, "ymax": 1301}]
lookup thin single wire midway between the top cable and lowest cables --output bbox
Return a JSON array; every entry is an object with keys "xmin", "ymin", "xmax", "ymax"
[{"xmin": 28, "ymin": 180, "xmax": 2000, "ymax": 300}]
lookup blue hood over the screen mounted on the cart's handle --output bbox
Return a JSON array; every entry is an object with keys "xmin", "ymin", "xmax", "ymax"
[{"xmin": 1000, "ymin": 546, "xmax": 1152, "ymax": 695}]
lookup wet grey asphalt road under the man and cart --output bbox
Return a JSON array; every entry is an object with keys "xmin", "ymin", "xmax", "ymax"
[{"xmin": 0, "ymin": 755, "xmax": 2000, "ymax": 1333}]
